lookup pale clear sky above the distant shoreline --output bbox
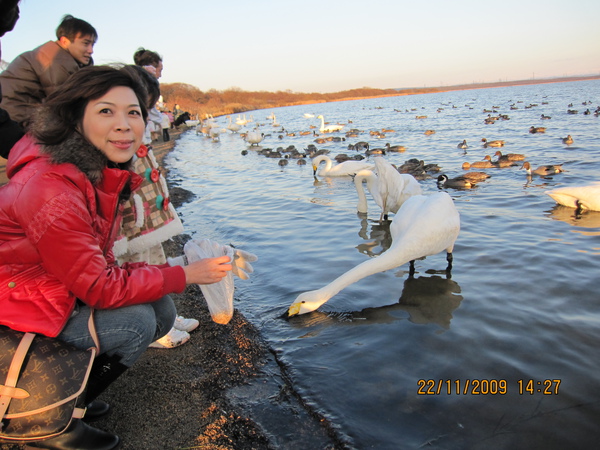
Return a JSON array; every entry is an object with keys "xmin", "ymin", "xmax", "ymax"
[{"xmin": 0, "ymin": 0, "xmax": 600, "ymax": 93}]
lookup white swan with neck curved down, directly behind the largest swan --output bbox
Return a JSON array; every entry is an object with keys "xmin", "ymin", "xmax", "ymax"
[{"xmin": 354, "ymin": 157, "xmax": 423, "ymax": 221}]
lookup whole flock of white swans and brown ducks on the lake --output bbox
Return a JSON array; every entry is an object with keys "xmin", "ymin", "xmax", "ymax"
[{"xmin": 190, "ymin": 99, "xmax": 600, "ymax": 316}]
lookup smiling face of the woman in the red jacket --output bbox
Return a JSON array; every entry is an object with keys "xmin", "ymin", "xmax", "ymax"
[{"xmin": 82, "ymin": 86, "xmax": 146, "ymax": 163}]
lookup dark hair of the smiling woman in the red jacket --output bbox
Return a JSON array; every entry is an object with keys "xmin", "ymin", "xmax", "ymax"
[{"xmin": 31, "ymin": 66, "xmax": 148, "ymax": 145}]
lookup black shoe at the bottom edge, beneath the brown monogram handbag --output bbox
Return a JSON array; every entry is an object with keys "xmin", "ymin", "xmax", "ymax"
[{"xmin": 25, "ymin": 419, "xmax": 121, "ymax": 450}]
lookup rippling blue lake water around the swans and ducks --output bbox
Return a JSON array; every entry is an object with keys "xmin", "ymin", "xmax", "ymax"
[{"xmin": 166, "ymin": 80, "xmax": 600, "ymax": 449}]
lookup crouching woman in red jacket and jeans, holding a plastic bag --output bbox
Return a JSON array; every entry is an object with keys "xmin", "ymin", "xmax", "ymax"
[{"xmin": 0, "ymin": 66, "xmax": 232, "ymax": 450}]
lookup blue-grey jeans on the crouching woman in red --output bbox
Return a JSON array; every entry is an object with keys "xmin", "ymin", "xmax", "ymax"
[{"xmin": 57, "ymin": 295, "xmax": 176, "ymax": 367}]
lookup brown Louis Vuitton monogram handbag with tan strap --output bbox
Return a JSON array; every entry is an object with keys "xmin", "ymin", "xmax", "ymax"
[{"xmin": 0, "ymin": 311, "xmax": 99, "ymax": 443}]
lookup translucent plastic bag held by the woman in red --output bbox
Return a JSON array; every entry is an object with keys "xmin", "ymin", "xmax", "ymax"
[{"xmin": 183, "ymin": 239, "xmax": 234, "ymax": 325}]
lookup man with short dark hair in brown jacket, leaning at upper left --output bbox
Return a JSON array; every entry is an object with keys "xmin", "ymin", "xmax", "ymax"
[{"xmin": 0, "ymin": 14, "xmax": 98, "ymax": 134}]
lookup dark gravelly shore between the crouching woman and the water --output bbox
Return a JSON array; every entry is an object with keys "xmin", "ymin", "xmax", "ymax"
[{"xmin": 0, "ymin": 127, "xmax": 349, "ymax": 450}]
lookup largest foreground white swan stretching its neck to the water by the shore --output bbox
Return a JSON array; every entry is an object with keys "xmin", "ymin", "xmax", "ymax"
[{"xmin": 288, "ymin": 192, "xmax": 460, "ymax": 316}]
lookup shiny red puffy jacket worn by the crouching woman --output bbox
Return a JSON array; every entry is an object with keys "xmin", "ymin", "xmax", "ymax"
[{"xmin": 0, "ymin": 135, "xmax": 185, "ymax": 337}]
